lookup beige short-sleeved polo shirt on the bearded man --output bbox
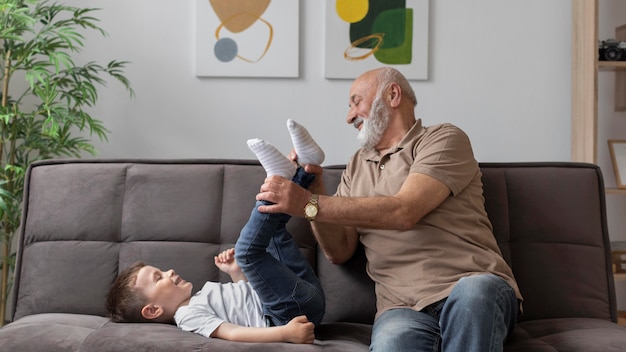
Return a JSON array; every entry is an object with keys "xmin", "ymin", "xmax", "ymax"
[{"xmin": 336, "ymin": 120, "xmax": 522, "ymax": 316}]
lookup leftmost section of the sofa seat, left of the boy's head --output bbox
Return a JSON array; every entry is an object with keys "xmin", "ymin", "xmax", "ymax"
[{"xmin": 0, "ymin": 313, "xmax": 108, "ymax": 352}]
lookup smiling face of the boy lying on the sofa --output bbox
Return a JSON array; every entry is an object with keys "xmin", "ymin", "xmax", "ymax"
[{"xmin": 136, "ymin": 265, "xmax": 193, "ymax": 317}]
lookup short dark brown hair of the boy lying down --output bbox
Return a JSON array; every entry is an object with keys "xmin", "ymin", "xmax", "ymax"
[{"xmin": 106, "ymin": 262, "xmax": 149, "ymax": 323}]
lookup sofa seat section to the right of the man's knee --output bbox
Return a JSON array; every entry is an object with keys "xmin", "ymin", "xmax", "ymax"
[{"xmin": 504, "ymin": 318, "xmax": 626, "ymax": 352}]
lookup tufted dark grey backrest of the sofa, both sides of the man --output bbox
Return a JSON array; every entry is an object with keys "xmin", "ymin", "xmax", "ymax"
[{"xmin": 13, "ymin": 160, "xmax": 615, "ymax": 323}]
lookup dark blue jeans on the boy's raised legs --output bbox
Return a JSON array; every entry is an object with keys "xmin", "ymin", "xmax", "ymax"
[{"xmin": 235, "ymin": 167, "xmax": 325, "ymax": 326}]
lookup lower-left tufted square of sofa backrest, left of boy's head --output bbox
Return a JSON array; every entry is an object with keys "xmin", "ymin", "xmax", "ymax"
[{"xmin": 15, "ymin": 240, "xmax": 119, "ymax": 318}]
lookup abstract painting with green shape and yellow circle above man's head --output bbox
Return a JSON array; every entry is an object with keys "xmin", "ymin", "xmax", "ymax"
[{"xmin": 325, "ymin": 0, "xmax": 429, "ymax": 80}]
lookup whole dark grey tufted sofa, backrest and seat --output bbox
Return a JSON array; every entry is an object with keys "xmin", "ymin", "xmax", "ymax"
[{"xmin": 0, "ymin": 160, "xmax": 626, "ymax": 352}]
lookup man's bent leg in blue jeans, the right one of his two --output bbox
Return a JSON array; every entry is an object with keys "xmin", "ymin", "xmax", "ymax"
[{"xmin": 440, "ymin": 274, "xmax": 519, "ymax": 352}]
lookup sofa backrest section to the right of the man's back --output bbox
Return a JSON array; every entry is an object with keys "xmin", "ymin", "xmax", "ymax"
[{"xmin": 480, "ymin": 163, "xmax": 616, "ymax": 321}]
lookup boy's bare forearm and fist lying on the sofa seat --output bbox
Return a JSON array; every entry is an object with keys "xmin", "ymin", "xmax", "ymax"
[{"xmin": 211, "ymin": 315, "xmax": 315, "ymax": 343}]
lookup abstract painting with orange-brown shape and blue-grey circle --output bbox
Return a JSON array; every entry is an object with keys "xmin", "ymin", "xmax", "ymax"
[{"xmin": 195, "ymin": 0, "xmax": 299, "ymax": 77}]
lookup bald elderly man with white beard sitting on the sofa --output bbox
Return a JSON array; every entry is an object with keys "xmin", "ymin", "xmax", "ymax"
[{"xmin": 257, "ymin": 67, "xmax": 522, "ymax": 352}]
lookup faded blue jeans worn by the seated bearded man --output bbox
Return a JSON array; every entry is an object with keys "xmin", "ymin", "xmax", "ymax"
[{"xmin": 370, "ymin": 274, "xmax": 519, "ymax": 352}]
